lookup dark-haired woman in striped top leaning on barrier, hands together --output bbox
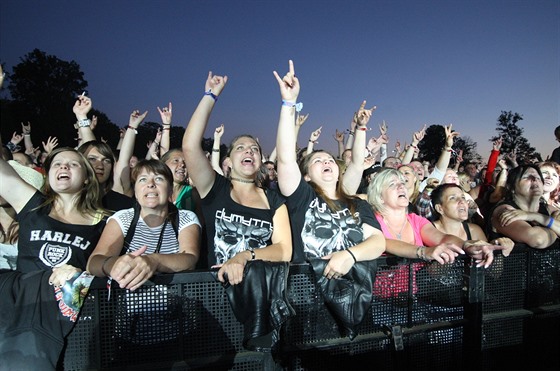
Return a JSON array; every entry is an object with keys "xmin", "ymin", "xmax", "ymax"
[{"xmin": 88, "ymin": 159, "xmax": 200, "ymax": 290}]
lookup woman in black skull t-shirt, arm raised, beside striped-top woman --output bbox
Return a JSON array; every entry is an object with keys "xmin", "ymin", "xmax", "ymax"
[{"xmin": 183, "ymin": 72, "xmax": 293, "ymax": 284}]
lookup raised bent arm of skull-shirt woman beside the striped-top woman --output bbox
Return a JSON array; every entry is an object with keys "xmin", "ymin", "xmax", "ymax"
[{"xmin": 183, "ymin": 71, "xmax": 228, "ymax": 198}]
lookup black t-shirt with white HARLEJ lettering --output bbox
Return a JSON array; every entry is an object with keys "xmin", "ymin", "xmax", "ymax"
[{"xmin": 16, "ymin": 191, "xmax": 105, "ymax": 273}]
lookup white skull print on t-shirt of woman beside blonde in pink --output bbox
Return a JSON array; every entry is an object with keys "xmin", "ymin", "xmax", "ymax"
[{"xmin": 301, "ymin": 198, "xmax": 363, "ymax": 258}]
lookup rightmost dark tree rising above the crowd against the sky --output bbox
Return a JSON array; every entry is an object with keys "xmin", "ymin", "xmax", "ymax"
[{"xmin": 490, "ymin": 111, "xmax": 542, "ymax": 164}]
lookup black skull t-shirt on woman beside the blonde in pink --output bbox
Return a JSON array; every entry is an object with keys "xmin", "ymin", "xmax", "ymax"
[{"xmin": 286, "ymin": 178, "xmax": 381, "ymax": 263}]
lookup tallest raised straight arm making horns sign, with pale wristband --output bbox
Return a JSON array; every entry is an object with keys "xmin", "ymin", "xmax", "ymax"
[{"xmin": 273, "ymin": 60, "xmax": 301, "ymax": 196}]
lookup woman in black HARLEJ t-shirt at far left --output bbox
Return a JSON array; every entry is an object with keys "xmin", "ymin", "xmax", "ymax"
[{"xmin": 0, "ymin": 147, "xmax": 105, "ymax": 370}]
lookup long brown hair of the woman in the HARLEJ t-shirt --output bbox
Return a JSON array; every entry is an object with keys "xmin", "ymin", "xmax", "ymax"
[{"xmin": 40, "ymin": 147, "xmax": 107, "ymax": 215}]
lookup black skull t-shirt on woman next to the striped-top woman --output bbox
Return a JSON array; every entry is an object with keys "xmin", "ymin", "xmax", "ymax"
[{"xmin": 201, "ymin": 174, "xmax": 285, "ymax": 268}]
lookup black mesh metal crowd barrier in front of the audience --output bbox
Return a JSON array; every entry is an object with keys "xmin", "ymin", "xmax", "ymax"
[{"xmin": 63, "ymin": 243, "xmax": 560, "ymax": 371}]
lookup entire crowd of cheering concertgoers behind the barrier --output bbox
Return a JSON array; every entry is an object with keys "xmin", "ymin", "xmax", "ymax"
[{"xmin": 0, "ymin": 61, "xmax": 560, "ymax": 369}]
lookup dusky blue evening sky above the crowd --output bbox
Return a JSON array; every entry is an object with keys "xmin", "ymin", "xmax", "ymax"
[{"xmin": 0, "ymin": 0, "xmax": 560, "ymax": 159}]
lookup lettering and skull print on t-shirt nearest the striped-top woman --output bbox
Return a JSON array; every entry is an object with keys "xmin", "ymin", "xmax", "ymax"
[{"xmin": 214, "ymin": 209, "xmax": 272, "ymax": 264}]
